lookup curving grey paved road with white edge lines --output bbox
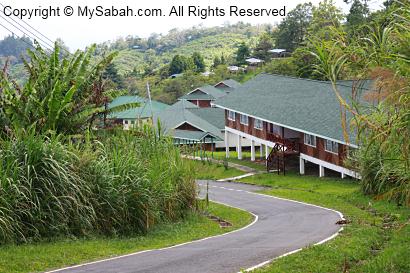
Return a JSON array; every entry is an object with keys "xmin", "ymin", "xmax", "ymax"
[{"xmin": 50, "ymin": 181, "xmax": 341, "ymax": 273}]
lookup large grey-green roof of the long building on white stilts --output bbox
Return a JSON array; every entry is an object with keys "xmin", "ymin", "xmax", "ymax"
[{"xmin": 214, "ymin": 74, "xmax": 372, "ymax": 144}]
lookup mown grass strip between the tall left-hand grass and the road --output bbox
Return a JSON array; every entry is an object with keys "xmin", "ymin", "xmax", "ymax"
[{"xmin": 0, "ymin": 203, "xmax": 253, "ymax": 273}]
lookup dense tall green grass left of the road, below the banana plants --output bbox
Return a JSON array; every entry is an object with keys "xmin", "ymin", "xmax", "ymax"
[{"xmin": 0, "ymin": 128, "xmax": 195, "ymax": 243}]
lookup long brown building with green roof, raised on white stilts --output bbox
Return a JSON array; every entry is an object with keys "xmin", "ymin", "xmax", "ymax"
[{"xmin": 213, "ymin": 74, "xmax": 359, "ymax": 178}]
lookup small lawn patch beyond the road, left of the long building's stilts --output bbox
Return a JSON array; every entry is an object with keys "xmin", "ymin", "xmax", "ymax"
[{"xmin": 188, "ymin": 157, "xmax": 245, "ymax": 180}]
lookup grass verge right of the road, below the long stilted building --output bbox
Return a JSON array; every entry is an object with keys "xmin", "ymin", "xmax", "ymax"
[{"xmin": 237, "ymin": 173, "xmax": 410, "ymax": 273}]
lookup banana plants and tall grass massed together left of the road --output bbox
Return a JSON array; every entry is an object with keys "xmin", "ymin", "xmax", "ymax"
[{"xmin": 0, "ymin": 44, "xmax": 195, "ymax": 244}]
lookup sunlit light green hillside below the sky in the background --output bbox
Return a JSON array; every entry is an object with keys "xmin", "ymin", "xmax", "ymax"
[{"xmin": 98, "ymin": 23, "xmax": 270, "ymax": 76}]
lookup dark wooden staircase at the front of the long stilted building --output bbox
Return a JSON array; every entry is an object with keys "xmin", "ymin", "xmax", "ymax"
[{"xmin": 266, "ymin": 139, "xmax": 299, "ymax": 175}]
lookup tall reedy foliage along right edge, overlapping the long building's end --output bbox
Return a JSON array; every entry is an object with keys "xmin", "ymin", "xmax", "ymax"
[{"xmin": 311, "ymin": 1, "xmax": 410, "ymax": 205}]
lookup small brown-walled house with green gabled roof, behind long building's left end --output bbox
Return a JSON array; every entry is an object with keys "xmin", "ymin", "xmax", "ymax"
[{"xmin": 178, "ymin": 85, "xmax": 227, "ymax": 107}]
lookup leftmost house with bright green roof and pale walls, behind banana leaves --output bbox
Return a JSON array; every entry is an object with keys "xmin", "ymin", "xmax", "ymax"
[{"xmin": 107, "ymin": 96, "xmax": 169, "ymax": 130}]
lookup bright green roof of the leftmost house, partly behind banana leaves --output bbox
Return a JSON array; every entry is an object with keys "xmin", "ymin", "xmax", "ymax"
[{"xmin": 108, "ymin": 96, "xmax": 169, "ymax": 119}]
